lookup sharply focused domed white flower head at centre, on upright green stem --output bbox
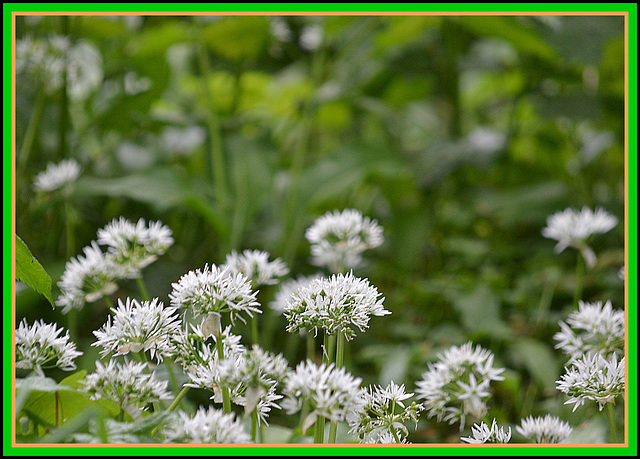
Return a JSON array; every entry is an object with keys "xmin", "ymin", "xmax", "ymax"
[{"xmin": 284, "ymin": 273, "xmax": 391, "ymax": 340}]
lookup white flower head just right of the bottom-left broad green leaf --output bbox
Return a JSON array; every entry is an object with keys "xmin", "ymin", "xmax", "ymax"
[{"xmin": 82, "ymin": 360, "xmax": 171, "ymax": 410}]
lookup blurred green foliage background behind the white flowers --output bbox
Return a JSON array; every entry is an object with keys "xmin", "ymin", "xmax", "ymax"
[{"xmin": 16, "ymin": 16, "xmax": 625, "ymax": 442}]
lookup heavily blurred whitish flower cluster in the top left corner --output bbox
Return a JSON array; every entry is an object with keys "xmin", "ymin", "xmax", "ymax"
[{"xmin": 16, "ymin": 35, "xmax": 103, "ymax": 101}]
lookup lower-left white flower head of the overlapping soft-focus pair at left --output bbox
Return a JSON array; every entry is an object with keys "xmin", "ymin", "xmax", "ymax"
[{"xmin": 56, "ymin": 241, "xmax": 123, "ymax": 314}]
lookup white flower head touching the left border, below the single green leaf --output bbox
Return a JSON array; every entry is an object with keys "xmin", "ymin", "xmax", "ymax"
[{"xmin": 16, "ymin": 319, "xmax": 82, "ymax": 375}]
